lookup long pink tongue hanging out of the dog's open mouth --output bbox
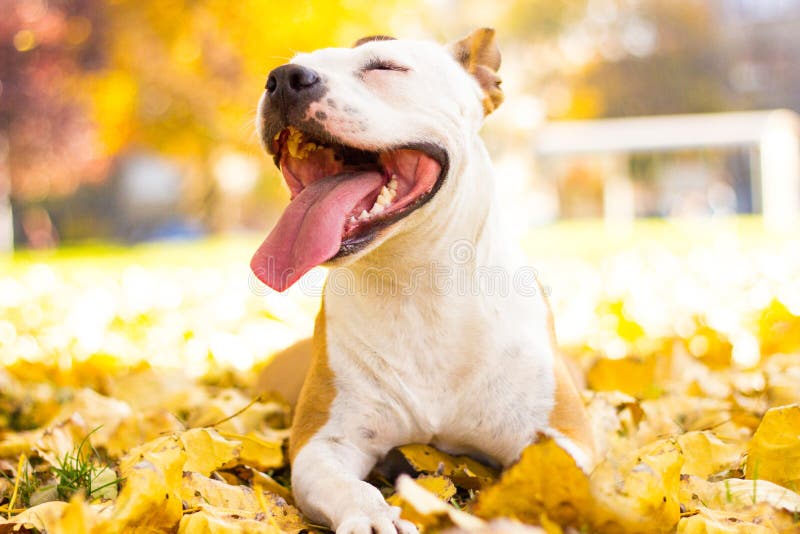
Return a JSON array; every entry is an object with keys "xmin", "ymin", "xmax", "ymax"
[{"xmin": 250, "ymin": 172, "xmax": 383, "ymax": 291}]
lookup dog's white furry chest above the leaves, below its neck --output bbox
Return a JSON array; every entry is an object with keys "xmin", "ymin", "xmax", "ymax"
[{"xmin": 327, "ymin": 292, "xmax": 554, "ymax": 463}]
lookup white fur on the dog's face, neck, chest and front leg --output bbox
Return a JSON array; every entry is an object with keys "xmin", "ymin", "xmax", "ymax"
[{"xmin": 276, "ymin": 41, "xmax": 578, "ymax": 534}]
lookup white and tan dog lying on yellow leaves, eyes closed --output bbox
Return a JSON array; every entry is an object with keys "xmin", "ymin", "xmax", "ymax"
[{"xmin": 251, "ymin": 28, "xmax": 594, "ymax": 534}]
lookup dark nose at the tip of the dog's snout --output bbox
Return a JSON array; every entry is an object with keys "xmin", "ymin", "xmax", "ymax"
[{"xmin": 265, "ymin": 64, "xmax": 325, "ymax": 122}]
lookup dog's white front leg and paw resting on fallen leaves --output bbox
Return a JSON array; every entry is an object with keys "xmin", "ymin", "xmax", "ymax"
[{"xmin": 292, "ymin": 437, "xmax": 417, "ymax": 534}]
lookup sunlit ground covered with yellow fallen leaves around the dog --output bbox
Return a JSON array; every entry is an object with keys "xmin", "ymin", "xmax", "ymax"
[{"xmin": 0, "ymin": 221, "xmax": 800, "ymax": 533}]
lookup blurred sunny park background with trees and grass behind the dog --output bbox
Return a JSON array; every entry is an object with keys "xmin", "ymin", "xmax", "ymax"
[{"xmin": 0, "ymin": 0, "xmax": 800, "ymax": 374}]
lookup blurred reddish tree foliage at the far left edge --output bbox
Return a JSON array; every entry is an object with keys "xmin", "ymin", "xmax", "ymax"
[{"xmin": 0, "ymin": 0, "xmax": 106, "ymax": 247}]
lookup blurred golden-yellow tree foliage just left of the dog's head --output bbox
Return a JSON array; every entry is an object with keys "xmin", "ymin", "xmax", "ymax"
[{"xmin": 84, "ymin": 0, "xmax": 406, "ymax": 230}]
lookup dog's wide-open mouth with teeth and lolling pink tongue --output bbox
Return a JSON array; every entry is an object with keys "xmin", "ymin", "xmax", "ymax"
[{"xmin": 251, "ymin": 126, "xmax": 447, "ymax": 291}]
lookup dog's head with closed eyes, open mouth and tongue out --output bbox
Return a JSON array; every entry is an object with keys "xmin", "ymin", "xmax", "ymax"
[{"xmin": 251, "ymin": 29, "xmax": 503, "ymax": 291}]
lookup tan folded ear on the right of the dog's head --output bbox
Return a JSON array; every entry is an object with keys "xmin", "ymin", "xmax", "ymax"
[{"xmin": 447, "ymin": 28, "xmax": 503, "ymax": 115}]
